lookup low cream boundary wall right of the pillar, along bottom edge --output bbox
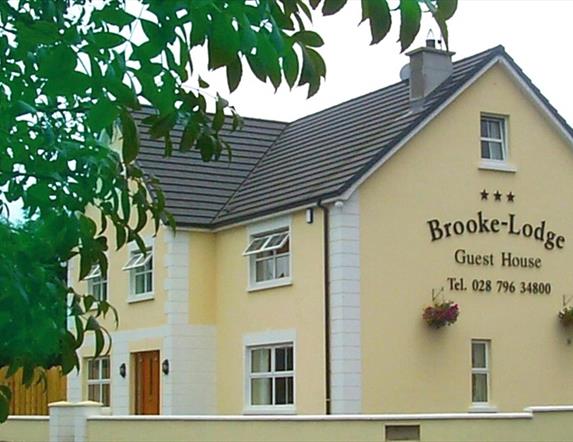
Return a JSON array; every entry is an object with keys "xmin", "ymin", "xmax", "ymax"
[{"xmin": 82, "ymin": 412, "xmax": 573, "ymax": 442}]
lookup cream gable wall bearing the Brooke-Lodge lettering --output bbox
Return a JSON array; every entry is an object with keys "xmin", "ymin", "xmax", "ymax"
[{"xmin": 360, "ymin": 67, "xmax": 573, "ymax": 412}]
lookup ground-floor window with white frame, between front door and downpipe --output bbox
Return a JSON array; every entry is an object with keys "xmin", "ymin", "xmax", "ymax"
[{"xmin": 247, "ymin": 343, "xmax": 294, "ymax": 407}]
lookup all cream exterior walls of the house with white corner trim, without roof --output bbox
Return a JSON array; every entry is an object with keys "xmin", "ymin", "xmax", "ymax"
[{"xmin": 68, "ymin": 60, "xmax": 573, "ymax": 415}]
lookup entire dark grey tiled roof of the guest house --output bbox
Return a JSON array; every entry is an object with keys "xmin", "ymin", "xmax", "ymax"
[{"xmin": 135, "ymin": 46, "xmax": 573, "ymax": 228}]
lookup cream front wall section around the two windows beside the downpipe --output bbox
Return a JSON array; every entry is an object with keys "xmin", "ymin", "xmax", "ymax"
[{"xmin": 214, "ymin": 210, "xmax": 325, "ymax": 414}]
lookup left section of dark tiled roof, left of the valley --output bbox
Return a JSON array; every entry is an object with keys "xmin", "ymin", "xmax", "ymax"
[{"xmin": 135, "ymin": 108, "xmax": 286, "ymax": 226}]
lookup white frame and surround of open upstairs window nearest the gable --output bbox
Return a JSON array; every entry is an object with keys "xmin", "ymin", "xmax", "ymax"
[{"xmin": 243, "ymin": 216, "xmax": 293, "ymax": 292}]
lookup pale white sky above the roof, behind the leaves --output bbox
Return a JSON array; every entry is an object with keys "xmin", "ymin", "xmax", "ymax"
[{"xmin": 193, "ymin": 0, "xmax": 573, "ymax": 124}]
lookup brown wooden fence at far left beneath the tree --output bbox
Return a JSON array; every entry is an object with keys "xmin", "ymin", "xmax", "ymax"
[{"xmin": 0, "ymin": 367, "xmax": 66, "ymax": 416}]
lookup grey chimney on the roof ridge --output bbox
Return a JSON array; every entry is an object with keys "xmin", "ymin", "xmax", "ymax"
[{"xmin": 406, "ymin": 38, "xmax": 454, "ymax": 110}]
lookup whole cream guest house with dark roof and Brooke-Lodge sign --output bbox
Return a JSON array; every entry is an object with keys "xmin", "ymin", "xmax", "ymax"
[{"xmin": 68, "ymin": 41, "xmax": 573, "ymax": 414}]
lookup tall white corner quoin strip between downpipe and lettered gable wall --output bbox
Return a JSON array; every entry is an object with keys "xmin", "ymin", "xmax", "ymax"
[{"xmin": 328, "ymin": 191, "xmax": 362, "ymax": 414}]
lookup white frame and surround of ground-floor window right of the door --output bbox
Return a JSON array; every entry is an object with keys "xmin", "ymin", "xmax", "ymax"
[{"xmin": 243, "ymin": 330, "xmax": 297, "ymax": 414}]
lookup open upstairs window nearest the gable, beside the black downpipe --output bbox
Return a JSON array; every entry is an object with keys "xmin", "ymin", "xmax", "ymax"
[{"xmin": 243, "ymin": 229, "xmax": 290, "ymax": 285}]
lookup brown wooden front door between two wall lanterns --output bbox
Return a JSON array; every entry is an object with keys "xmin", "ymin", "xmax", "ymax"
[{"xmin": 134, "ymin": 351, "xmax": 159, "ymax": 414}]
